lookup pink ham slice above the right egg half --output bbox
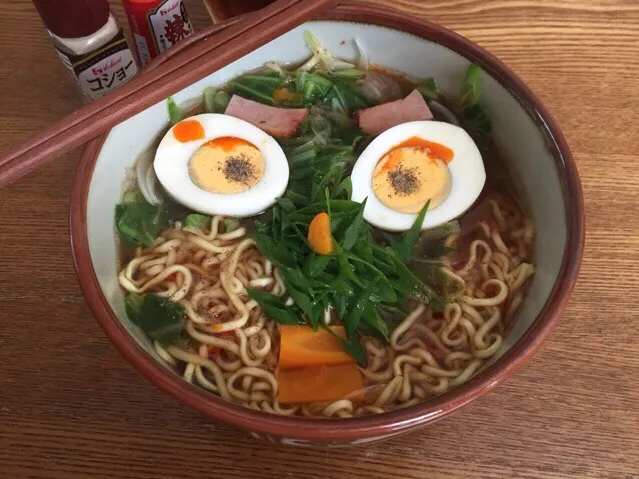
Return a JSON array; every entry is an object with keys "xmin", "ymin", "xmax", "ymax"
[{"xmin": 357, "ymin": 90, "xmax": 433, "ymax": 135}]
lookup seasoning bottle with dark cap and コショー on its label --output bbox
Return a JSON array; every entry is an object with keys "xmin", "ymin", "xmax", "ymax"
[{"xmin": 34, "ymin": 0, "xmax": 138, "ymax": 103}]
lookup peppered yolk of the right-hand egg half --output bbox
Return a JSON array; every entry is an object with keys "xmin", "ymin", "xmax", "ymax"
[{"xmin": 373, "ymin": 142, "xmax": 452, "ymax": 213}]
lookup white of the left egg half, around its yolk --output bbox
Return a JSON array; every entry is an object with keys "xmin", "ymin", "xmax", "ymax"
[{"xmin": 153, "ymin": 113, "xmax": 289, "ymax": 217}]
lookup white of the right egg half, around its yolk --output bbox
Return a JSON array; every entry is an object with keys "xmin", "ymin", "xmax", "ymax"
[{"xmin": 351, "ymin": 121, "xmax": 486, "ymax": 231}]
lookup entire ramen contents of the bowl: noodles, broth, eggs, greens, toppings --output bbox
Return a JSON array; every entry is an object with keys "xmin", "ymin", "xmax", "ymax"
[{"xmin": 116, "ymin": 32, "xmax": 534, "ymax": 418}]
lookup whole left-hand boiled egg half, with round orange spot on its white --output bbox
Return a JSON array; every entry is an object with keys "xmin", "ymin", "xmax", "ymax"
[{"xmin": 153, "ymin": 113, "xmax": 289, "ymax": 217}]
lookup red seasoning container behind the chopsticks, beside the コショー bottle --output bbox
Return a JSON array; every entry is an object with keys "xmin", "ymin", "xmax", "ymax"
[{"xmin": 122, "ymin": 0, "xmax": 193, "ymax": 65}]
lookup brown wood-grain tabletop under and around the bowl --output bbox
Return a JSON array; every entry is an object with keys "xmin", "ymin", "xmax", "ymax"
[{"xmin": 0, "ymin": 0, "xmax": 639, "ymax": 479}]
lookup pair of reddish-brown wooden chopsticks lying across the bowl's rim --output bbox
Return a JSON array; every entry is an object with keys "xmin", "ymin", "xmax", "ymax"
[{"xmin": 0, "ymin": 0, "xmax": 339, "ymax": 187}]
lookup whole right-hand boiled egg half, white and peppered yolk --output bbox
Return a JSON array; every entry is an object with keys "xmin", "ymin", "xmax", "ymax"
[{"xmin": 351, "ymin": 121, "xmax": 486, "ymax": 231}]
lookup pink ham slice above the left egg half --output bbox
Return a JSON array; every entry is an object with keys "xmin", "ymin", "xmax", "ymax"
[{"xmin": 226, "ymin": 95, "xmax": 308, "ymax": 137}]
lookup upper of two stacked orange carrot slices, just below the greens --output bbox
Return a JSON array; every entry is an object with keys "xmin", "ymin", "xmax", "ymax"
[{"xmin": 279, "ymin": 325, "xmax": 355, "ymax": 369}]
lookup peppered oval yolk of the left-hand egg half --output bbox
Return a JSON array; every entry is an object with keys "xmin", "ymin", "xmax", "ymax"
[{"xmin": 189, "ymin": 136, "xmax": 266, "ymax": 194}]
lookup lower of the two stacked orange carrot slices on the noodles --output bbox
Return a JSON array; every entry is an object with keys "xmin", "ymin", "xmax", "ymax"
[{"xmin": 278, "ymin": 364, "xmax": 364, "ymax": 404}]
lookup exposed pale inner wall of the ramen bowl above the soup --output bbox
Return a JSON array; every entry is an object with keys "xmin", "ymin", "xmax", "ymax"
[{"xmin": 81, "ymin": 21, "xmax": 568, "ymax": 432}]
